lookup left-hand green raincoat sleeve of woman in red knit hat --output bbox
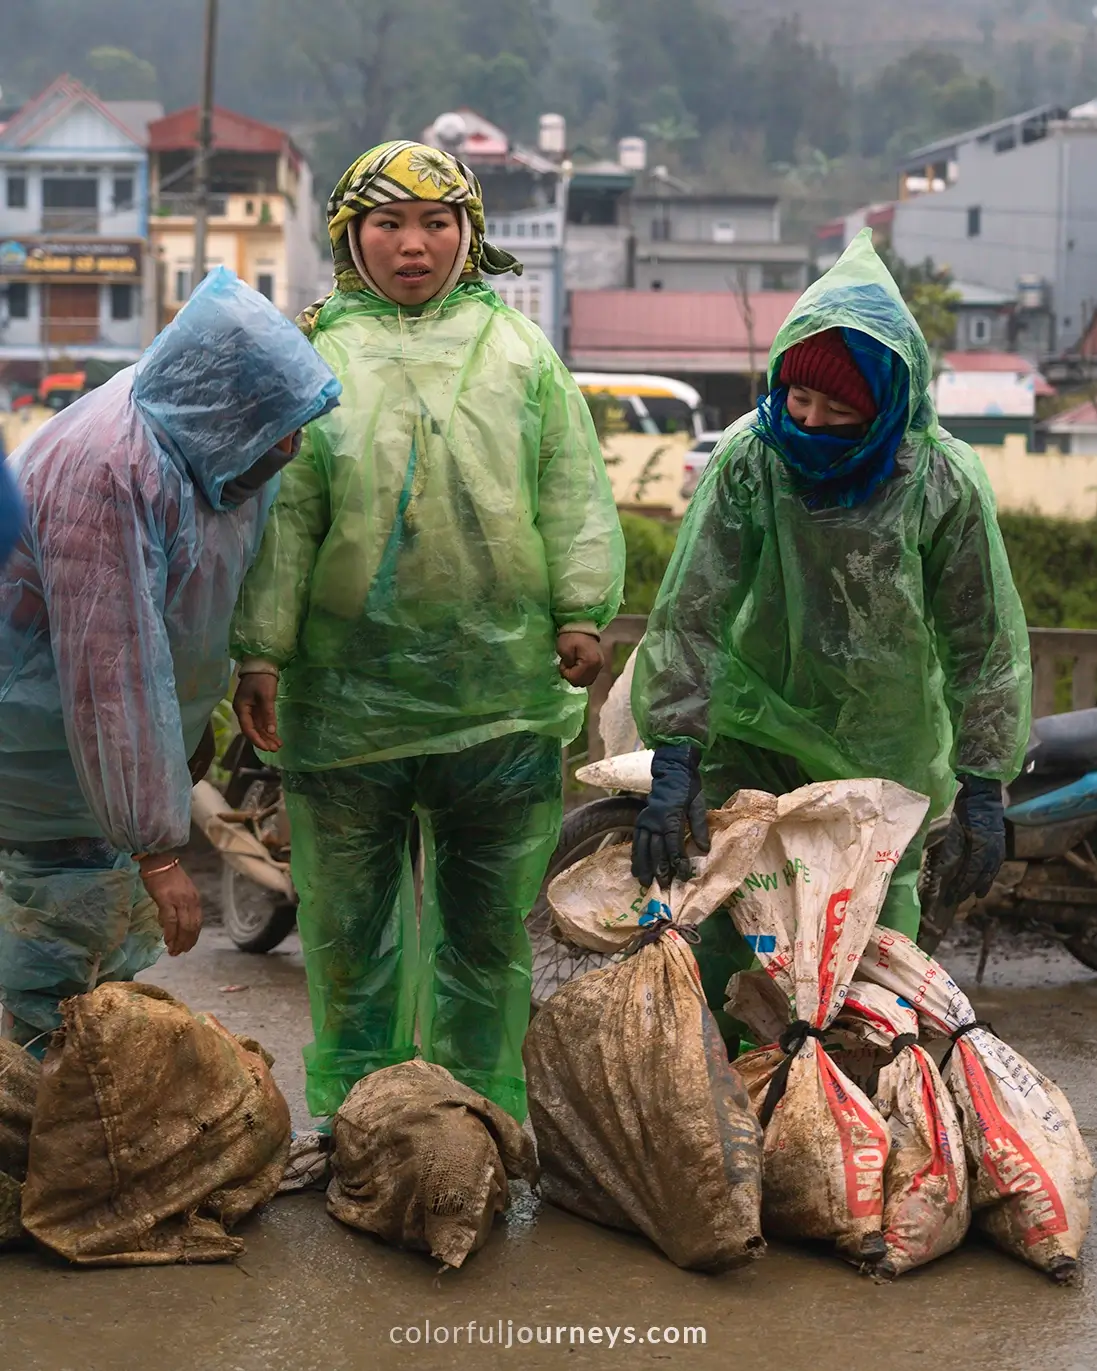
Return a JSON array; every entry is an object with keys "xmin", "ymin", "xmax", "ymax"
[{"xmin": 632, "ymin": 435, "xmax": 757, "ymax": 749}]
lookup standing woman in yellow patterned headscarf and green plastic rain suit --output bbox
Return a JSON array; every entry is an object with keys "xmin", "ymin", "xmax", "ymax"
[{"xmin": 234, "ymin": 143, "xmax": 624, "ymax": 1119}]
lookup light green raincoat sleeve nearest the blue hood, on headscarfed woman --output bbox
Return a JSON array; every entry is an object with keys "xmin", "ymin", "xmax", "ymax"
[{"xmin": 232, "ymin": 424, "xmax": 328, "ymax": 666}]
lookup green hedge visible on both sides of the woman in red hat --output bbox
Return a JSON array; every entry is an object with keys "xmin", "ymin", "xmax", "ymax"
[{"xmin": 621, "ymin": 514, "xmax": 1097, "ymax": 628}]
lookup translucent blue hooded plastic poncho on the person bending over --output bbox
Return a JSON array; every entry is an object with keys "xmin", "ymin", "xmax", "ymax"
[{"xmin": 0, "ymin": 269, "xmax": 340, "ymax": 853}]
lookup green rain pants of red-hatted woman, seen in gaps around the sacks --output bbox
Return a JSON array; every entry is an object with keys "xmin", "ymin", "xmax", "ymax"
[{"xmin": 694, "ymin": 739, "xmax": 928, "ymax": 1057}]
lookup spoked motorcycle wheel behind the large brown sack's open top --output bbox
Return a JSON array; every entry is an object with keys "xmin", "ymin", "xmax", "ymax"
[{"xmin": 525, "ymin": 795, "xmax": 644, "ymax": 1013}]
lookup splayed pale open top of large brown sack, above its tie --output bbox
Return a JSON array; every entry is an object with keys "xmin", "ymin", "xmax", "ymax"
[{"xmin": 547, "ymin": 790, "xmax": 777, "ymax": 953}]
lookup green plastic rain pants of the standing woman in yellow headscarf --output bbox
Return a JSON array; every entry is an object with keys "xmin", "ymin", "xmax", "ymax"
[{"xmin": 284, "ymin": 732, "xmax": 564, "ymax": 1121}]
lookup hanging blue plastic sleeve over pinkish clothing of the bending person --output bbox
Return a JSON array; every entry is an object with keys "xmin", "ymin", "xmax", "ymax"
[{"xmin": 36, "ymin": 462, "xmax": 191, "ymax": 853}]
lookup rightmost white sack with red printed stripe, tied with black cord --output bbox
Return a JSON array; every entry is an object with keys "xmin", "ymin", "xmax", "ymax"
[{"xmin": 858, "ymin": 928, "xmax": 1094, "ymax": 1282}]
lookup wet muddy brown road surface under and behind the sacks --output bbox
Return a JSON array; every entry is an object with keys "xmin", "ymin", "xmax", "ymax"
[{"xmin": 0, "ymin": 893, "xmax": 1097, "ymax": 1371}]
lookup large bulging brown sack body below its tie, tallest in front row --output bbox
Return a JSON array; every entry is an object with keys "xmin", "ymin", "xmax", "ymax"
[{"xmin": 525, "ymin": 921, "xmax": 765, "ymax": 1271}]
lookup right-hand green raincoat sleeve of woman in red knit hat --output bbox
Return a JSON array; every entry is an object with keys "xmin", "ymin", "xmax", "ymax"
[{"xmin": 923, "ymin": 444, "xmax": 1031, "ymax": 784}]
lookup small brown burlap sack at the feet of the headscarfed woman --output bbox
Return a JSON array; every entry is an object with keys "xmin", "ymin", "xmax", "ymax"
[{"xmin": 328, "ymin": 1058, "xmax": 538, "ymax": 1267}]
